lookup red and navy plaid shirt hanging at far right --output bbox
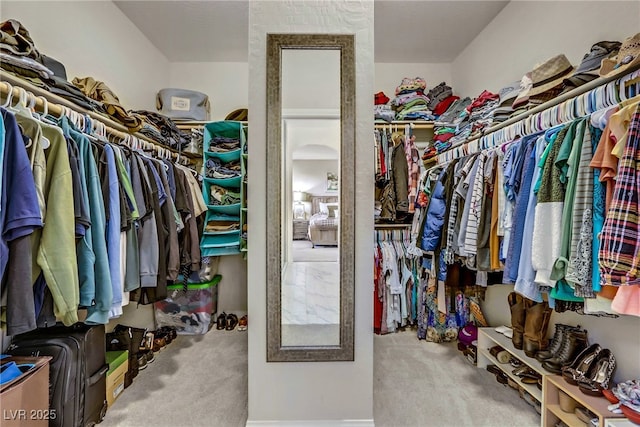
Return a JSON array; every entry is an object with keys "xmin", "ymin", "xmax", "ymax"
[{"xmin": 598, "ymin": 107, "xmax": 640, "ymax": 285}]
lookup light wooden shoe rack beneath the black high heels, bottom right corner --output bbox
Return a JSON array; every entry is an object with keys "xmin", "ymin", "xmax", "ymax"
[{"xmin": 542, "ymin": 375, "xmax": 624, "ymax": 427}]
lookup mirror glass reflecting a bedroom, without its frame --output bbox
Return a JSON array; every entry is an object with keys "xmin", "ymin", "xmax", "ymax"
[{"xmin": 280, "ymin": 49, "xmax": 341, "ymax": 347}]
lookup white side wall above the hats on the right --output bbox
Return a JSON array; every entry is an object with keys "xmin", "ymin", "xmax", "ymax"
[{"xmin": 451, "ymin": 1, "xmax": 640, "ymax": 97}]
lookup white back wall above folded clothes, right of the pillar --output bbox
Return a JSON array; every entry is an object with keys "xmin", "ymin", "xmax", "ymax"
[{"xmin": 371, "ymin": 62, "xmax": 457, "ymax": 98}]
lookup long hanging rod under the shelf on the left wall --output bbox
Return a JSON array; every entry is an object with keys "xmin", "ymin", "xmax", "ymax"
[{"xmin": 0, "ymin": 70, "xmax": 200, "ymax": 164}]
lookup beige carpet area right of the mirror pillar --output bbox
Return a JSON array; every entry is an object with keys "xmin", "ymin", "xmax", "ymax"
[{"xmin": 373, "ymin": 331, "xmax": 540, "ymax": 427}]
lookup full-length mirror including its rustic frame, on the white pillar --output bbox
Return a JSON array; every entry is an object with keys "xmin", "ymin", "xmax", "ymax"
[{"xmin": 267, "ymin": 34, "xmax": 355, "ymax": 362}]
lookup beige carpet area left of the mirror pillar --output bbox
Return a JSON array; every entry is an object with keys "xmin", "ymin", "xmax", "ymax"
[{"xmin": 99, "ymin": 328, "xmax": 248, "ymax": 427}]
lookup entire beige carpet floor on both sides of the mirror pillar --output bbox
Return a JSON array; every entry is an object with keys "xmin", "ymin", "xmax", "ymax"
[{"xmin": 100, "ymin": 329, "xmax": 540, "ymax": 427}]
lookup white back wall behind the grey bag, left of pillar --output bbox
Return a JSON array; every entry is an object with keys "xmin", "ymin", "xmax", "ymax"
[{"xmin": 169, "ymin": 62, "xmax": 249, "ymax": 121}]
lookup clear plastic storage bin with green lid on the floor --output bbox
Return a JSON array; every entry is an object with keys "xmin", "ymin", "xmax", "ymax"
[{"xmin": 155, "ymin": 274, "xmax": 222, "ymax": 335}]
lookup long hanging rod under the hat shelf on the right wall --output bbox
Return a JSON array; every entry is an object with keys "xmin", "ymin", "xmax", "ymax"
[{"xmin": 437, "ymin": 64, "xmax": 640, "ymax": 161}]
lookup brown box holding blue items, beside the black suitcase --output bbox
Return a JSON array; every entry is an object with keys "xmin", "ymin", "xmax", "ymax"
[{"xmin": 0, "ymin": 356, "xmax": 51, "ymax": 427}]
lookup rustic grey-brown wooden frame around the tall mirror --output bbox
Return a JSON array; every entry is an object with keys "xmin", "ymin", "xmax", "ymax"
[{"xmin": 266, "ymin": 34, "xmax": 356, "ymax": 362}]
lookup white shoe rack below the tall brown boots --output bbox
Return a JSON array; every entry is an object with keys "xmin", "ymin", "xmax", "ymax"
[{"xmin": 477, "ymin": 327, "xmax": 549, "ymax": 404}]
